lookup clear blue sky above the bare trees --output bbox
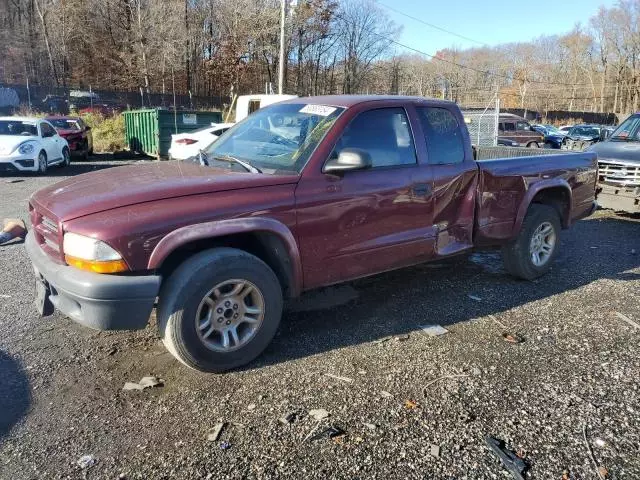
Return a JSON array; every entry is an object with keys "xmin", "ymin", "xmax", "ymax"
[{"xmin": 378, "ymin": 0, "xmax": 617, "ymax": 53}]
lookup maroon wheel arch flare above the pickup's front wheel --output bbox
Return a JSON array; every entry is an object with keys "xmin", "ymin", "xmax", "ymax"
[{"xmin": 148, "ymin": 218, "xmax": 302, "ymax": 297}]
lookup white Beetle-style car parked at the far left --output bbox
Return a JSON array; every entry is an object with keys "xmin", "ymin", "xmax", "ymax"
[{"xmin": 0, "ymin": 117, "xmax": 71, "ymax": 173}]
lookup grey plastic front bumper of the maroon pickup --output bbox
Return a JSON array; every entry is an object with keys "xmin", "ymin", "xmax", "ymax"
[{"xmin": 25, "ymin": 232, "xmax": 161, "ymax": 330}]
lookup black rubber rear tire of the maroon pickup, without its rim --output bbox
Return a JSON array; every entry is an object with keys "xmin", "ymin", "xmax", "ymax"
[{"xmin": 502, "ymin": 203, "xmax": 561, "ymax": 280}]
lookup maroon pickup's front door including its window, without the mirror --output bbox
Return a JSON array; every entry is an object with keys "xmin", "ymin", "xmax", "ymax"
[{"xmin": 296, "ymin": 106, "xmax": 435, "ymax": 288}]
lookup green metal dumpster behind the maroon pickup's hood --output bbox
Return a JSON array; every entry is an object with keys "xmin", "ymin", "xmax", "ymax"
[{"xmin": 123, "ymin": 108, "xmax": 222, "ymax": 158}]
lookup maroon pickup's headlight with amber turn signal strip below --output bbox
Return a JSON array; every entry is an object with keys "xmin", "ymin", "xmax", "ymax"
[{"xmin": 62, "ymin": 232, "xmax": 129, "ymax": 273}]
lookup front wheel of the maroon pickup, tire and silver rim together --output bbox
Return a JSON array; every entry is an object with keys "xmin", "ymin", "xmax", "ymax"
[{"xmin": 158, "ymin": 248, "xmax": 282, "ymax": 373}]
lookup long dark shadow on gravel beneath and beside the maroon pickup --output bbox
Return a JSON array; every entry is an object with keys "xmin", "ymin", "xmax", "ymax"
[{"xmin": 247, "ymin": 217, "xmax": 640, "ymax": 369}]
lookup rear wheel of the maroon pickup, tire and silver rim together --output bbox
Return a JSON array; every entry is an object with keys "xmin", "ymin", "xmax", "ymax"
[{"xmin": 502, "ymin": 204, "xmax": 560, "ymax": 280}]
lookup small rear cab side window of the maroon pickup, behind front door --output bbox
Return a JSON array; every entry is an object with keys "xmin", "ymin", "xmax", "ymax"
[{"xmin": 417, "ymin": 107, "xmax": 464, "ymax": 165}]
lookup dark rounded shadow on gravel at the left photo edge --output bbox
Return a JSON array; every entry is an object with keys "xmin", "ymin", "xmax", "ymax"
[{"xmin": 0, "ymin": 351, "xmax": 31, "ymax": 440}]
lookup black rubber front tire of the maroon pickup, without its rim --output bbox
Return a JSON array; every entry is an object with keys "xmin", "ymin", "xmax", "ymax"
[{"xmin": 157, "ymin": 248, "xmax": 283, "ymax": 373}]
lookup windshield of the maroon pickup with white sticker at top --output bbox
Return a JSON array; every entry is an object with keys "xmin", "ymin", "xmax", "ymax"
[{"xmin": 205, "ymin": 103, "xmax": 344, "ymax": 172}]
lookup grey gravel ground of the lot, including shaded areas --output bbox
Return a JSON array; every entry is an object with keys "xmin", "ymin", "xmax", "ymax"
[{"xmin": 0, "ymin": 162, "xmax": 640, "ymax": 480}]
